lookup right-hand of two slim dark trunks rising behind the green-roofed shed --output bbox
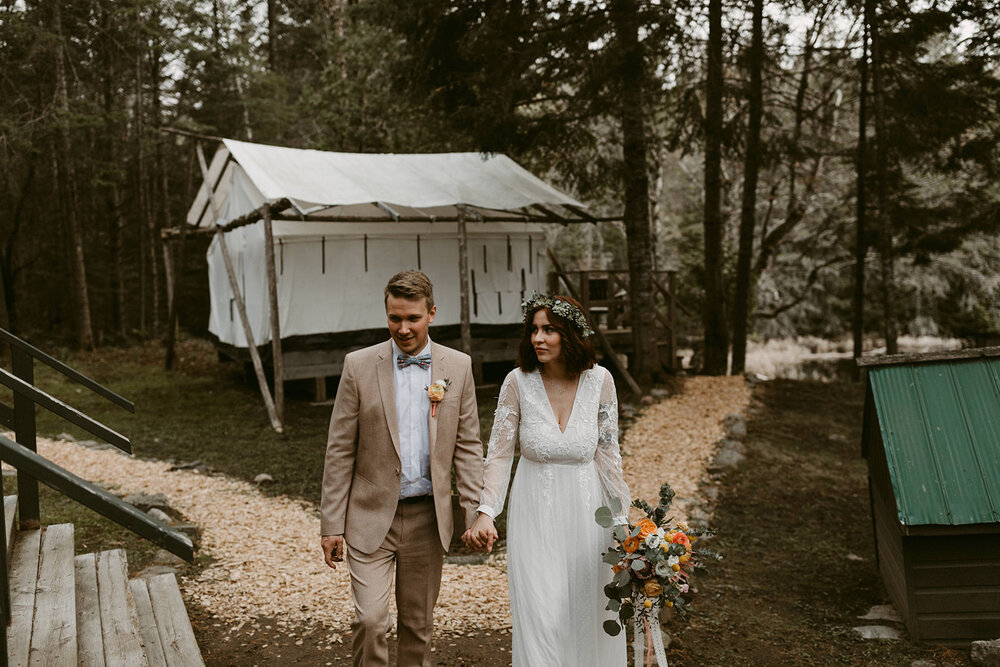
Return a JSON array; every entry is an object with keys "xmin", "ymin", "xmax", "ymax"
[{"xmin": 866, "ymin": 0, "xmax": 899, "ymax": 354}]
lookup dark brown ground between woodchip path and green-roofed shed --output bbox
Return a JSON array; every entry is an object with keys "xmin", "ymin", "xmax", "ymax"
[{"xmin": 669, "ymin": 380, "xmax": 967, "ymax": 667}]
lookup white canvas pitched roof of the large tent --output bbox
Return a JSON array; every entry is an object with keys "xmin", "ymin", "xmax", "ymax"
[{"xmin": 187, "ymin": 139, "xmax": 584, "ymax": 227}]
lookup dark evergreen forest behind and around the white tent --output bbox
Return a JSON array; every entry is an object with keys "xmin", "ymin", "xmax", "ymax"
[{"xmin": 0, "ymin": 0, "xmax": 1000, "ymax": 382}]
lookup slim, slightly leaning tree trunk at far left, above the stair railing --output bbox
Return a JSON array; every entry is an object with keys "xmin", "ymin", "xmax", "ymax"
[{"xmin": 52, "ymin": 0, "xmax": 94, "ymax": 349}]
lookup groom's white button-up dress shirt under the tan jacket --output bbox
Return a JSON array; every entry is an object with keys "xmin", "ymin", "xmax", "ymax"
[{"xmin": 392, "ymin": 338, "xmax": 434, "ymax": 498}]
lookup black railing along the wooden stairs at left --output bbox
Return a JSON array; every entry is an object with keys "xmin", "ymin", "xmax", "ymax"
[{"xmin": 0, "ymin": 329, "xmax": 194, "ymax": 667}]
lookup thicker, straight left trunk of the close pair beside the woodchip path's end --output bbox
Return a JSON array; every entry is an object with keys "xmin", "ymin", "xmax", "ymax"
[{"xmin": 702, "ymin": 0, "xmax": 729, "ymax": 375}]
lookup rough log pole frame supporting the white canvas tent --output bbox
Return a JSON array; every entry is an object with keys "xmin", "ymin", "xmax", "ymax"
[{"xmin": 161, "ymin": 134, "xmax": 642, "ymax": 433}]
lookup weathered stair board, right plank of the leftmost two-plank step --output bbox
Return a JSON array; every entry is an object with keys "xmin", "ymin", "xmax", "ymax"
[{"xmin": 29, "ymin": 523, "xmax": 76, "ymax": 667}]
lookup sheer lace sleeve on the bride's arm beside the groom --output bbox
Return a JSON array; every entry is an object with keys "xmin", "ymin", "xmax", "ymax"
[{"xmin": 479, "ymin": 371, "xmax": 521, "ymax": 519}]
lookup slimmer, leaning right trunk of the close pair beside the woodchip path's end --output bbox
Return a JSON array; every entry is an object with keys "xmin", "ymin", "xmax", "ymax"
[{"xmin": 732, "ymin": 0, "xmax": 764, "ymax": 375}]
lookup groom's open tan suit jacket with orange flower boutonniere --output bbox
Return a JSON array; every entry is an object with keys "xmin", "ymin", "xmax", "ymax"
[{"xmin": 320, "ymin": 341, "xmax": 483, "ymax": 553}]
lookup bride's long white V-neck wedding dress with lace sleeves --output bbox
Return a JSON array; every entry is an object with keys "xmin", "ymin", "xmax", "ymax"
[{"xmin": 479, "ymin": 366, "xmax": 630, "ymax": 667}]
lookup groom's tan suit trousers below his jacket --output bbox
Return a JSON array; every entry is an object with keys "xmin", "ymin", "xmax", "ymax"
[{"xmin": 347, "ymin": 497, "xmax": 444, "ymax": 667}]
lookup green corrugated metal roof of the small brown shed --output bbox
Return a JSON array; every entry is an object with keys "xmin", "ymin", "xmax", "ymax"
[{"xmin": 868, "ymin": 358, "xmax": 1000, "ymax": 526}]
